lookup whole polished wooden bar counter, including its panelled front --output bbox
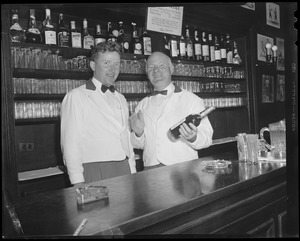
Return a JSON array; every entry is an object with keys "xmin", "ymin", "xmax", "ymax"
[{"xmin": 14, "ymin": 154, "xmax": 286, "ymax": 238}]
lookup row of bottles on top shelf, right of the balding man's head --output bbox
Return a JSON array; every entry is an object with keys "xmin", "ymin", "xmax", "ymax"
[{"xmin": 164, "ymin": 25, "xmax": 242, "ymax": 64}]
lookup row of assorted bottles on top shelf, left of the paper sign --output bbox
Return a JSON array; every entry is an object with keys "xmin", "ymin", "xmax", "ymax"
[{"xmin": 10, "ymin": 8, "xmax": 152, "ymax": 55}]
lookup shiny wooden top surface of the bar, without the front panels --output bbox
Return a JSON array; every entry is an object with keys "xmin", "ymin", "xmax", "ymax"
[{"xmin": 14, "ymin": 153, "xmax": 286, "ymax": 237}]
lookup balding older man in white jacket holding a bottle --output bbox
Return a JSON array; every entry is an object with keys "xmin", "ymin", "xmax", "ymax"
[{"xmin": 130, "ymin": 52, "xmax": 213, "ymax": 170}]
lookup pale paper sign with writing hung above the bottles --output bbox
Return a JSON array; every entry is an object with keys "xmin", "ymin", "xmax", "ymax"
[{"xmin": 147, "ymin": 7, "xmax": 183, "ymax": 36}]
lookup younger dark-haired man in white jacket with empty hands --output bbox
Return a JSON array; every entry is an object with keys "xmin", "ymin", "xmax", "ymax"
[{"xmin": 61, "ymin": 43, "xmax": 136, "ymax": 186}]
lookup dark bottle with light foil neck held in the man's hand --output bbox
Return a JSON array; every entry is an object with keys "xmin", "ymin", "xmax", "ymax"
[{"xmin": 168, "ymin": 106, "xmax": 216, "ymax": 141}]
